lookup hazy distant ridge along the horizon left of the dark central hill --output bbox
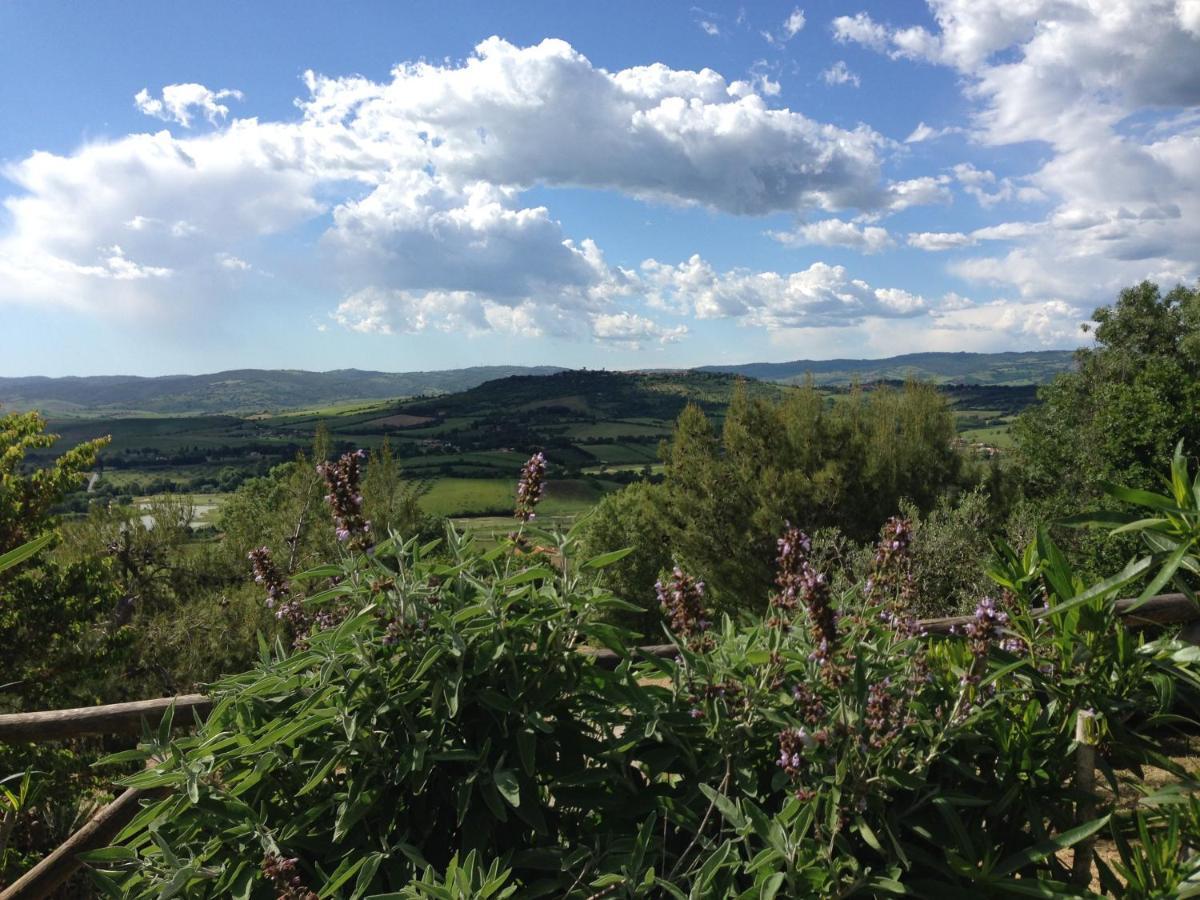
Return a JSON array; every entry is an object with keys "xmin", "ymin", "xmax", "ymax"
[{"xmin": 0, "ymin": 366, "xmax": 562, "ymax": 416}]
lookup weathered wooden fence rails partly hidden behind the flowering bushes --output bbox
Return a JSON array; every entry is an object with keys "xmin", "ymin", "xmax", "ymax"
[{"xmin": 0, "ymin": 594, "xmax": 1200, "ymax": 900}]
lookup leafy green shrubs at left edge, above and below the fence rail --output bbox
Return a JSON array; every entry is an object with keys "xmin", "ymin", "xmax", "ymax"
[{"xmin": 0, "ymin": 413, "xmax": 121, "ymax": 880}]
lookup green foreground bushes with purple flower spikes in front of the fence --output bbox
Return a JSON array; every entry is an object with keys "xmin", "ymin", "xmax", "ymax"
[{"xmin": 91, "ymin": 451, "xmax": 1200, "ymax": 898}]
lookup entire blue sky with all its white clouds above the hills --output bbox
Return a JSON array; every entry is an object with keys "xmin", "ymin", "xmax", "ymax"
[{"xmin": 0, "ymin": 0, "xmax": 1200, "ymax": 376}]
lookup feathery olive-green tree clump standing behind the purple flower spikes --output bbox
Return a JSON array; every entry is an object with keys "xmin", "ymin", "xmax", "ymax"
[{"xmin": 635, "ymin": 383, "xmax": 970, "ymax": 608}]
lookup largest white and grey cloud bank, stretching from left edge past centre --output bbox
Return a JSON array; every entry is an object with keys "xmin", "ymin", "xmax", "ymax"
[{"xmin": 0, "ymin": 33, "xmax": 892, "ymax": 341}]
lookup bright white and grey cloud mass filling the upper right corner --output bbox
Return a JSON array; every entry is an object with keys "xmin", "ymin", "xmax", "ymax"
[{"xmin": 834, "ymin": 0, "xmax": 1200, "ymax": 299}]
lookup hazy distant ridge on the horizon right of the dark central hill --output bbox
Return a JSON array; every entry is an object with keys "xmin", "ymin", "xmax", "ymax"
[{"xmin": 697, "ymin": 350, "xmax": 1074, "ymax": 384}]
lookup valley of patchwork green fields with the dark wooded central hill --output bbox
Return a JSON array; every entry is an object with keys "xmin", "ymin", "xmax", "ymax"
[{"xmin": 42, "ymin": 372, "xmax": 1034, "ymax": 523}]
